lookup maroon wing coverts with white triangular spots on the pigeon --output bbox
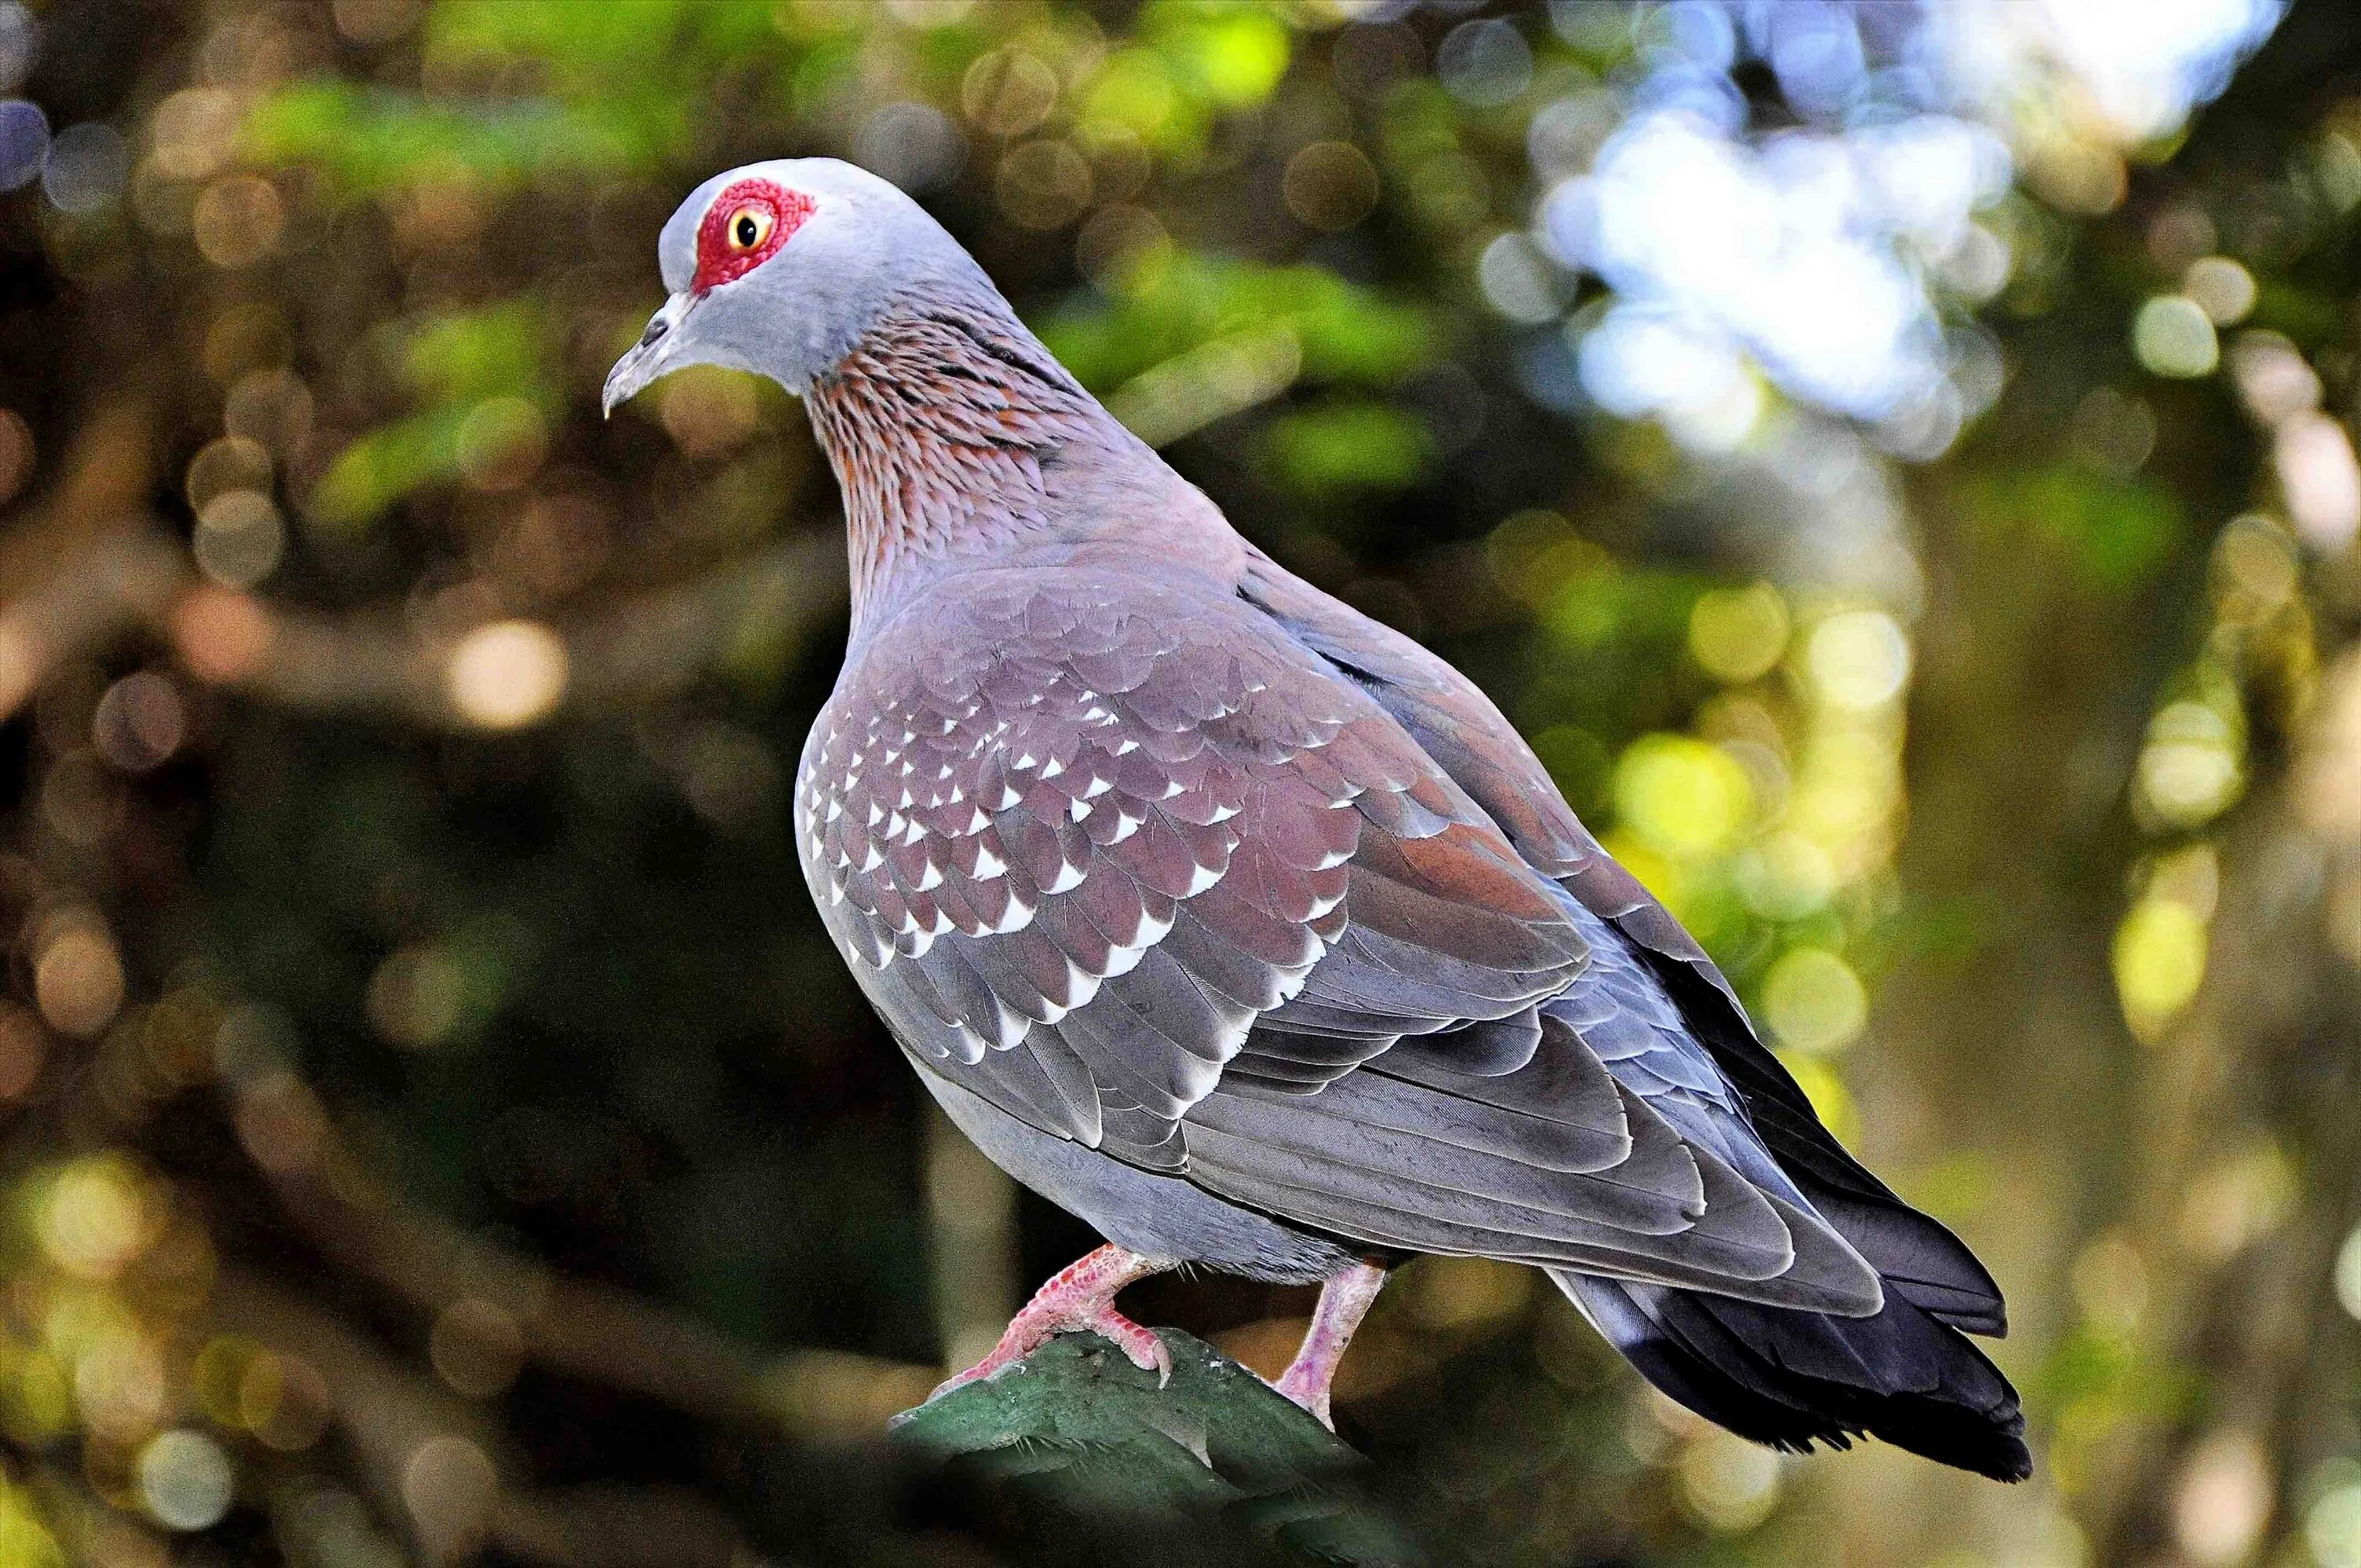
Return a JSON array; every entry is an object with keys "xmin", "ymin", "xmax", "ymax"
[{"xmin": 796, "ymin": 569, "xmax": 1587, "ymax": 1169}]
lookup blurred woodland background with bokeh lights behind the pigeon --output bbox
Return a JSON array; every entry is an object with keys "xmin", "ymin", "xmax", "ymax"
[{"xmin": 0, "ymin": 0, "xmax": 2361, "ymax": 1568}]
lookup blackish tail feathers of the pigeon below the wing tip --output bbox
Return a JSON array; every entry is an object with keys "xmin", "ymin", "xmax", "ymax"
[{"xmin": 1549, "ymin": 1268, "xmax": 2033, "ymax": 1481}]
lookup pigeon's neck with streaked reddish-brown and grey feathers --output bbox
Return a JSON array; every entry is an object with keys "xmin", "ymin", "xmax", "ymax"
[{"xmin": 805, "ymin": 286, "xmax": 1211, "ymax": 637}]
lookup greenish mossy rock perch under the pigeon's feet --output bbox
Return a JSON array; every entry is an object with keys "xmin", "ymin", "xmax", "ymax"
[{"xmin": 890, "ymin": 1330, "xmax": 1424, "ymax": 1568}]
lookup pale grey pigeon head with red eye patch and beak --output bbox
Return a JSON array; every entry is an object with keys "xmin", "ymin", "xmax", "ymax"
[{"xmin": 604, "ymin": 158, "xmax": 989, "ymax": 413}]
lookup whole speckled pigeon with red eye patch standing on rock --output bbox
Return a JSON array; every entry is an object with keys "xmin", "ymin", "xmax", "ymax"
[{"xmin": 607, "ymin": 158, "xmax": 2028, "ymax": 1478}]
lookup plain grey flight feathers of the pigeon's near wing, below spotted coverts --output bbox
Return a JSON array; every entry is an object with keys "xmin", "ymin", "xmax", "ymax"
[{"xmin": 1188, "ymin": 887, "xmax": 1882, "ymax": 1313}]
